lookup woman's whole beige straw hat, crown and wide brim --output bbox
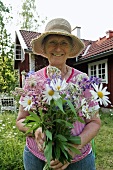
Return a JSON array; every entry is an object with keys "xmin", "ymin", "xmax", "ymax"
[{"xmin": 31, "ymin": 18, "xmax": 84, "ymax": 58}]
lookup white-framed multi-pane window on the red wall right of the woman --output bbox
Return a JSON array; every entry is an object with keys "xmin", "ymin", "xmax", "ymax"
[{"xmin": 88, "ymin": 59, "xmax": 108, "ymax": 84}]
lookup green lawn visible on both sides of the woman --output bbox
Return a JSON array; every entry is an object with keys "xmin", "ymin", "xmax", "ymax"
[{"xmin": 0, "ymin": 109, "xmax": 113, "ymax": 170}]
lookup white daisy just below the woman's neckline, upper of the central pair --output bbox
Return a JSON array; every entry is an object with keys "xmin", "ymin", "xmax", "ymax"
[{"xmin": 50, "ymin": 78, "xmax": 67, "ymax": 91}]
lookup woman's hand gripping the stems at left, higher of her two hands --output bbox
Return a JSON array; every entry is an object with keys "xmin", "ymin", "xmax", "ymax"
[{"xmin": 35, "ymin": 127, "xmax": 45, "ymax": 152}]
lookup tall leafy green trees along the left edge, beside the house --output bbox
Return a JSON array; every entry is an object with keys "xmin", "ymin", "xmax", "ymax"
[{"xmin": 0, "ymin": 1, "xmax": 17, "ymax": 93}]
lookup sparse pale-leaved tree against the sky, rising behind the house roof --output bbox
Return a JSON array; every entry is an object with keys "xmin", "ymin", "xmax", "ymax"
[{"xmin": 19, "ymin": 0, "xmax": 47, "ymax": 31}]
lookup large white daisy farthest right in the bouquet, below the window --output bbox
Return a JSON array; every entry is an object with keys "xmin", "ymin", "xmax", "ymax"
[{"xmin": 90, "ymin": 83, "xmax": 111, "ymax": 106}]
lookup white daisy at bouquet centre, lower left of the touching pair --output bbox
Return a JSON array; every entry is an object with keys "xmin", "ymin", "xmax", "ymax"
[{"xmin": 43, "ymin": 84, "xmax": 61, "ymax": 104}]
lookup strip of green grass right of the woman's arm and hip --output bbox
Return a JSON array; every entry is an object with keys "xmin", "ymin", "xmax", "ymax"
[{"xmin": 95, "ymin": 112, "xmax": 113, "ymax": 170}]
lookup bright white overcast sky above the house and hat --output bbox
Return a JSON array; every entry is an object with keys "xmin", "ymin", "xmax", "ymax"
[{"xmin": 2, "ymin": 0, "xmax": 113, "ymax": 40}]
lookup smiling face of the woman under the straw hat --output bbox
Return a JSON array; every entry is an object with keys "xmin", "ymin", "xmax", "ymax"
[{"xmin": 44, "ymin": 35, "xmax": 72, "ymax": 66}]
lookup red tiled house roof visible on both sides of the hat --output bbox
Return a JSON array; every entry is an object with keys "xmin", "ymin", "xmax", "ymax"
[{"xmin": 15, "ymin": 30, "xmax": 113, "ymax": 60}]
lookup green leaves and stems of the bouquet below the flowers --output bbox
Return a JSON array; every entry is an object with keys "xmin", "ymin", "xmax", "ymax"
[{"xmin": 24, "ymin": 95, "xmax": 81, "ymax": 165}]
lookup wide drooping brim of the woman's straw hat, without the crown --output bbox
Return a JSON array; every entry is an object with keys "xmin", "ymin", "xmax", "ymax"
[{"xmin": 31, "ymin": 30, "xmax": 85, "ymax": 58}]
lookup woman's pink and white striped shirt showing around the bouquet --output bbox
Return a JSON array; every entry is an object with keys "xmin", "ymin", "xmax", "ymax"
[{"xmin": 26, "ymin": 67, "xmax": 97, "ymax": 162}]
